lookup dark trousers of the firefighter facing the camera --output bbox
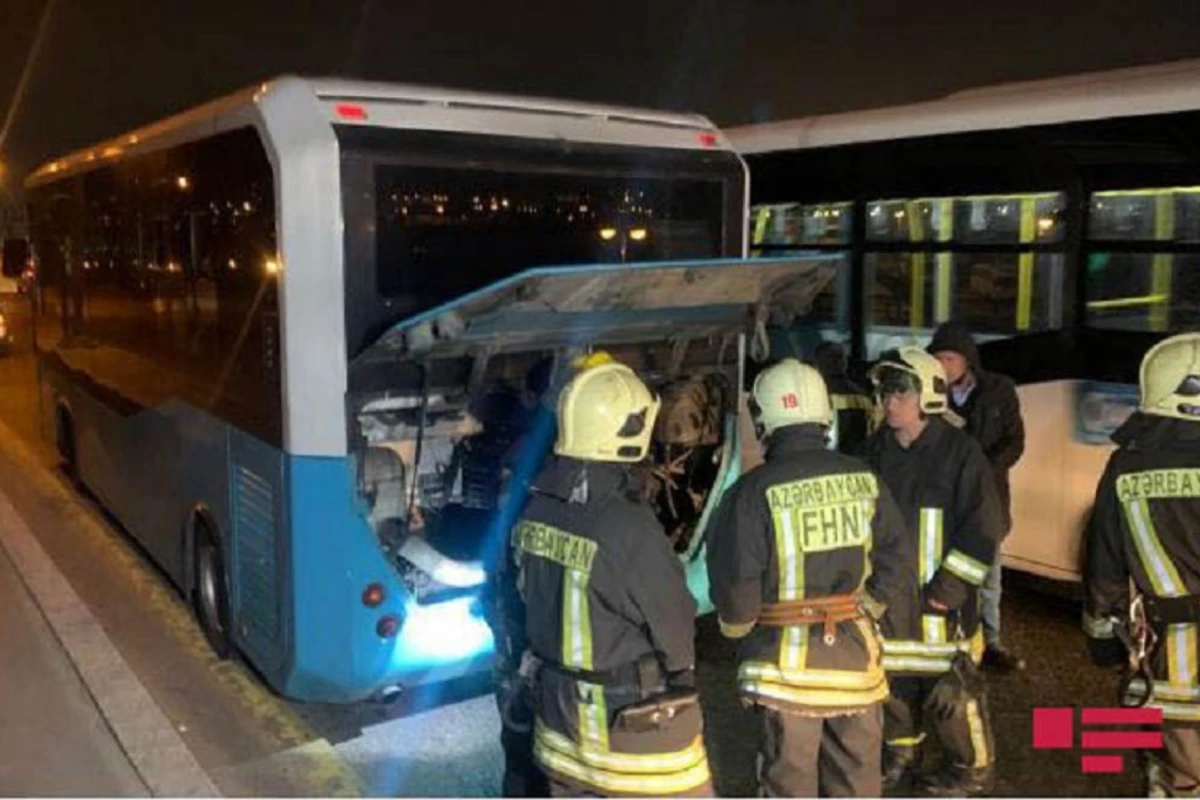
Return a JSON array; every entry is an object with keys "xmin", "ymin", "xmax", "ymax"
[{"xmin": 883, "ymin": 676, "xmax": 996, "ymax": 769}]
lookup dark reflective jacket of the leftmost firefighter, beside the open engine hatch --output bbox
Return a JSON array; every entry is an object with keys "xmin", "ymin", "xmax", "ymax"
[{"xmin": 512, "ymin": 457, "xmax": 709, "ymax": 795}]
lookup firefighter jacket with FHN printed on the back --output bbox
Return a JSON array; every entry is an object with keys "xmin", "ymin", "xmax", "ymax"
[{"xmin": 708, "ymin": 425, "xmax": 917, "ymax": 716}]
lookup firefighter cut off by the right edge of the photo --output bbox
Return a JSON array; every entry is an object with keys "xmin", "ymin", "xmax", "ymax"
[{"xmin": 1084, "ymin": 333, "xmax": 1200, "ymax": 796}]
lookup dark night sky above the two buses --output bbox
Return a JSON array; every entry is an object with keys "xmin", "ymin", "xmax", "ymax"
[{"xmin": 0, "ymin": 0, "xmax": 1200, "ymax": 188}]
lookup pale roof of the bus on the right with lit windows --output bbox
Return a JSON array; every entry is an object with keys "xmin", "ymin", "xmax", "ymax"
[{"xmin": 725, "ymin": 59, "xmax": 1200, "ymax": 155}]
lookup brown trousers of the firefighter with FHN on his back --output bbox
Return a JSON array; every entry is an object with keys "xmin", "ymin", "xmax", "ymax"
[{"xmin": 756, "ymin": 703, "xmax": 883, "ymax": 798}]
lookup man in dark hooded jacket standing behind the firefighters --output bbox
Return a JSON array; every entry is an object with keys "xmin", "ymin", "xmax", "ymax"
[{"xmin": 928, "ymin": 321, "xmax": 1025, "ymax": 672}]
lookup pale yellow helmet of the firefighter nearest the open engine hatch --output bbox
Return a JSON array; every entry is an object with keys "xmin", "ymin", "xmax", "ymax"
[{"xmin": 554, "ymin": 360, "xmax": 659, "ymax": 463}]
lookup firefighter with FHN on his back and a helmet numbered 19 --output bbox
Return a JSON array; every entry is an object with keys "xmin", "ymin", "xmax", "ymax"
[{"xmin": 708, "ymin": 359, "xmax": 917, "ymax": 798}]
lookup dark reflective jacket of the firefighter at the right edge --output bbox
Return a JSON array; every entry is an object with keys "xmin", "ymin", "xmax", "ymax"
[{"xmin": 1084, "ymin": 414, "xmax": 1200, "ymax": 722}]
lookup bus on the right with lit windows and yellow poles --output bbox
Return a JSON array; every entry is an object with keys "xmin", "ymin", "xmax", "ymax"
[{"xmin": 727, "ymin": 61, "xmax": 1200, "ymax": 582}]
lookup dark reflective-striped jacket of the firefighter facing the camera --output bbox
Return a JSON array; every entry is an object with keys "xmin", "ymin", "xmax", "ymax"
[{"xmin": 866, "ymin": 416, "xmax": 1003, "ymax": 675}]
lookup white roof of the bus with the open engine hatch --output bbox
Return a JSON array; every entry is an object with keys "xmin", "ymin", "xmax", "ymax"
[{"xmin": 25, "ymin": 76, "xmax": 728, "ymax": 186}]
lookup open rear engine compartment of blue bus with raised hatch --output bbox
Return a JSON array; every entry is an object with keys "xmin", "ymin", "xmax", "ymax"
[{"xmin": 347, "ymin": 255, "xmax": 840, "ymax": 618}]
